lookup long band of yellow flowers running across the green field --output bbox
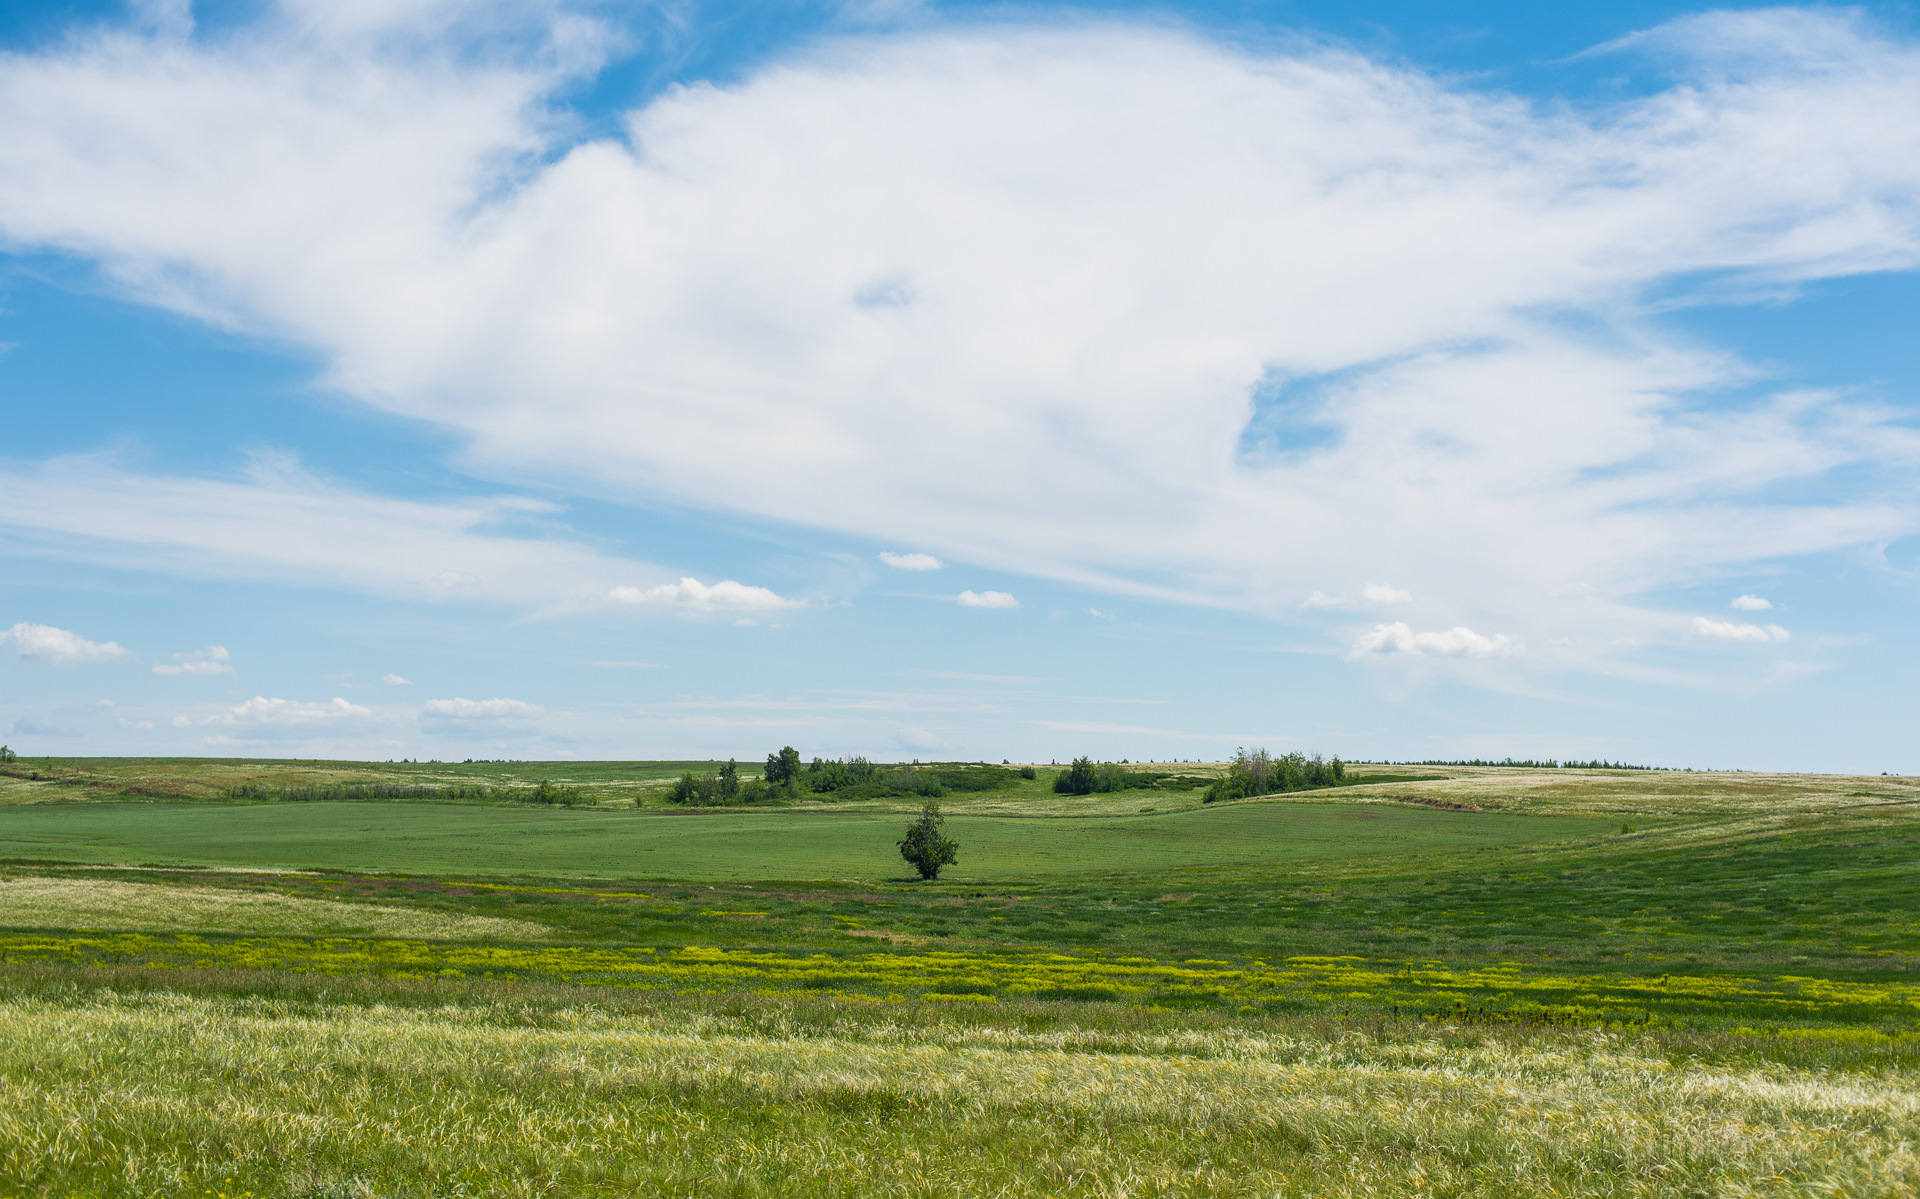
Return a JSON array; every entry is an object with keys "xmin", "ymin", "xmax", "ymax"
[{"xmin": 0, "ymin": 932, "xmax": 1920, "ymax": 1026}]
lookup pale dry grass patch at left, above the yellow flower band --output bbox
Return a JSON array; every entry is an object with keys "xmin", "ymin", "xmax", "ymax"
[{"xmin": 0, "ymin": 876, "xmax": 551, "ymax": 942}]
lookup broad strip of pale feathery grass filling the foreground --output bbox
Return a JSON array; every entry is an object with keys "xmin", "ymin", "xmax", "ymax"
[{"xmin": 0, "ymin": 995, "xmax": 1920, "ymax": 1199}]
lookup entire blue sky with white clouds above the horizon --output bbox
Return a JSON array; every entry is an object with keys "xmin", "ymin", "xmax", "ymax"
[{"xmin": 0, "ymin": 0, "xmax": 1920, "ymax": 774}]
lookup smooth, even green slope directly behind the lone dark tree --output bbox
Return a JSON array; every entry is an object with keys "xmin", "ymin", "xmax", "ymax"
[{"xmin": 0, "ymin": 803, "xmax": 1603, "ymax": 884}]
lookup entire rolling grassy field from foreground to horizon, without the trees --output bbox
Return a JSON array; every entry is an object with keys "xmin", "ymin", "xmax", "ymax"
[{"xmin": 0, "ymin": 761, "xmax": 1920, "ymax": 1197}]
